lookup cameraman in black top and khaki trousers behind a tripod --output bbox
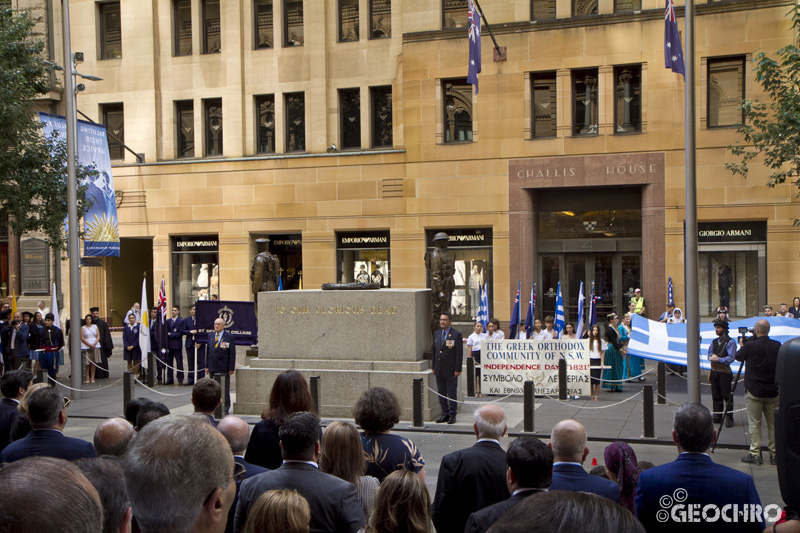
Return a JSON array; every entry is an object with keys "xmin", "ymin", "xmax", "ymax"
[{"xmin": 736, "ymin": 320, "xmax": 781, "ymax": 465}]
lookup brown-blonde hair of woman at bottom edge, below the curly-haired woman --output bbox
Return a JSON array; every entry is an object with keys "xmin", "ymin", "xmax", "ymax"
[{"xmin": 366, "ymin": 470, "xmax": 431, "ymax": 533}]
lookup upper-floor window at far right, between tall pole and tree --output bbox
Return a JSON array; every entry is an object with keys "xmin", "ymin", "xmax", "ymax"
[{"xmin": 708, "ymin": 57, "xmax": 744, "ymax": 128}]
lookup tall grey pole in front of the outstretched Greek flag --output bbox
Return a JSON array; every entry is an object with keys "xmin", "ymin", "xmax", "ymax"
[{"xmin": 683, "ymin": 0, "xmax": 700, "ymax": 403}]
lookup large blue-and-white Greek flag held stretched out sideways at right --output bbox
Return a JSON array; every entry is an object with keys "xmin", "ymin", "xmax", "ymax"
[{"xmin": 628, "ymin": 315, "xmax": 800, "ymax": 373}]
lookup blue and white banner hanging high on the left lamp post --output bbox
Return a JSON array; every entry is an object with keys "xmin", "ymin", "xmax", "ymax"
[{"xmin": 39, "ymin": 113, "xmax": 119, "ymax": 257}]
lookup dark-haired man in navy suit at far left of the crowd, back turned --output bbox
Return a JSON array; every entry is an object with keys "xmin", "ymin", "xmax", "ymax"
[{"xmin": 0, "ymin": 387, "xmax": 95, "ymax": 463}]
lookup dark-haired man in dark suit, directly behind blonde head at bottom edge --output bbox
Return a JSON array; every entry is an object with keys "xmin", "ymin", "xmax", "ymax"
[{"xmin": 234, "ymin": 411, "xmax": 366, "ymax": 533}]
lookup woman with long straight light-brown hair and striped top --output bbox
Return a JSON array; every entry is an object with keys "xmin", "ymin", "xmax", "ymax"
[{"xmin": 319, "ymin": 420, "xmax": 380, "ymax": 516}]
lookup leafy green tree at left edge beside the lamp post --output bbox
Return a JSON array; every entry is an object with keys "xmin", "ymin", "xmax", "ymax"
[{"xmin": 0, "ymin": 7, "xmax": 93, "ymax": 249}]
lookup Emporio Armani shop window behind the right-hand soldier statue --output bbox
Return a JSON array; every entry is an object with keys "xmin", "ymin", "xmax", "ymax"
[{"xmin": 425, "ymin": 228, "xmax": 494, "ymax": 322}]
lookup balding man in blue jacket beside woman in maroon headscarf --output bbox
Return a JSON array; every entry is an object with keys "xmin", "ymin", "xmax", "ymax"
[{"xmin": 548, "ymin": 420, "xmax": 619, "ymax": 502}]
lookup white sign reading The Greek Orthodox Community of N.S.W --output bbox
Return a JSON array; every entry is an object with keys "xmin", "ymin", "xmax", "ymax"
[{"xmin": 481, "ymin": 339, "xmax": 590, "ymax": 396}]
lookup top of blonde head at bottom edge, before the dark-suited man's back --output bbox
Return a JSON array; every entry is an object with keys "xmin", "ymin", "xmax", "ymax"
[{"xmin": 244, "ymin": 489, "xmax": 311, "ymax": 533}]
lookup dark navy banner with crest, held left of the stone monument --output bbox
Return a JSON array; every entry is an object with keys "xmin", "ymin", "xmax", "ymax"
[{"xmin": 194, "ymin": 300, "xmax": 258, "ymax": 346}]
